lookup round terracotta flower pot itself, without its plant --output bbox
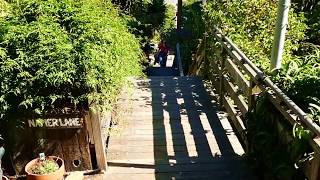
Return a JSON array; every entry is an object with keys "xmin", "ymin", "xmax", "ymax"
[{"xmin": 25, "ymin": 156, "xmax": 65, "ymax": 180}]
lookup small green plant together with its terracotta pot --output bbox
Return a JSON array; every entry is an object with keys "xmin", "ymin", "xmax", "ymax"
[{"xmin": 25, "ymin": 153, "xmax": 65, "ymax": 180}]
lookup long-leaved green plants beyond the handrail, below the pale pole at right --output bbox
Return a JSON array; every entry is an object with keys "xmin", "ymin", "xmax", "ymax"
[{"xmin": 274, "ymin": 48, "xmax": 320, "ymax": 114}]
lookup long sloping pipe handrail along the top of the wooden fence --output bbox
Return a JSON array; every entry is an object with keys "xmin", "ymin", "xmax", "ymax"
[{"xmin": 214, "ymin": 27, "xmax": 320, "ymax": 136}]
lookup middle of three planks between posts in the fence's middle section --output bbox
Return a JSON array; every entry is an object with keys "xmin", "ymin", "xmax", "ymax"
[{"xmin": 223, "ymin": 76, "xmax": 248, "ymax": 115}]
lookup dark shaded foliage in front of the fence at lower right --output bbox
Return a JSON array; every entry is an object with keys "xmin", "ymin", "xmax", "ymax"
[{"xmin": 247, "ymin": 96, "xmax": 311, "ymax": 180}]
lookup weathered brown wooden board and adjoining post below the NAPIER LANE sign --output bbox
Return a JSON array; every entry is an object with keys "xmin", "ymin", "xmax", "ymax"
[{"xmin": 11, "ymin": 107, "xmax": 111, "ymax": 174}]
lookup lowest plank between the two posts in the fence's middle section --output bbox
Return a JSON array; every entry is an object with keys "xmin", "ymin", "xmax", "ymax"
[{"xmin": 223, "ymin": 97, "xmax": 248, "ymax": 146}]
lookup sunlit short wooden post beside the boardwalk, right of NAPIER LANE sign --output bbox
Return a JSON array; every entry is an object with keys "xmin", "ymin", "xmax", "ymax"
[{"xmin": 90, "ymin": 111, "xmax": 111, "ymax": 171}]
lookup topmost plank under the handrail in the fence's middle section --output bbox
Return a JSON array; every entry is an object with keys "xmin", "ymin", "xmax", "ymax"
[{"xmin": 225, "ymin": 59, "xmax": 251, "ymax": 96}]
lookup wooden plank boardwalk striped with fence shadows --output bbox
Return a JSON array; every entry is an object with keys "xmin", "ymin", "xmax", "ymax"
[{"xmin": 105, "ymin": 76, "xmax": 253, "ymax": 180}]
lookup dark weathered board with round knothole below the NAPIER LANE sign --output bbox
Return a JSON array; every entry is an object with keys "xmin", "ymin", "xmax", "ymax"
[{"xmin": 11, "ymin": 118, "xmax": 92, "ymax": 174}]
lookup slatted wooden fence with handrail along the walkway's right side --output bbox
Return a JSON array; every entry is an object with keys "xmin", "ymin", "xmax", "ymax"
[{"xmin": 189, "ymin": 28, "xmax": 320, "ymax": 180}]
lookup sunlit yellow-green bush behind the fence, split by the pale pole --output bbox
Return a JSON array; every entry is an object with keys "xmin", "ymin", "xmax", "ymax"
[{"xmin": 206, "ymin": 0, "xmax": 306, "ymax": 70}]
